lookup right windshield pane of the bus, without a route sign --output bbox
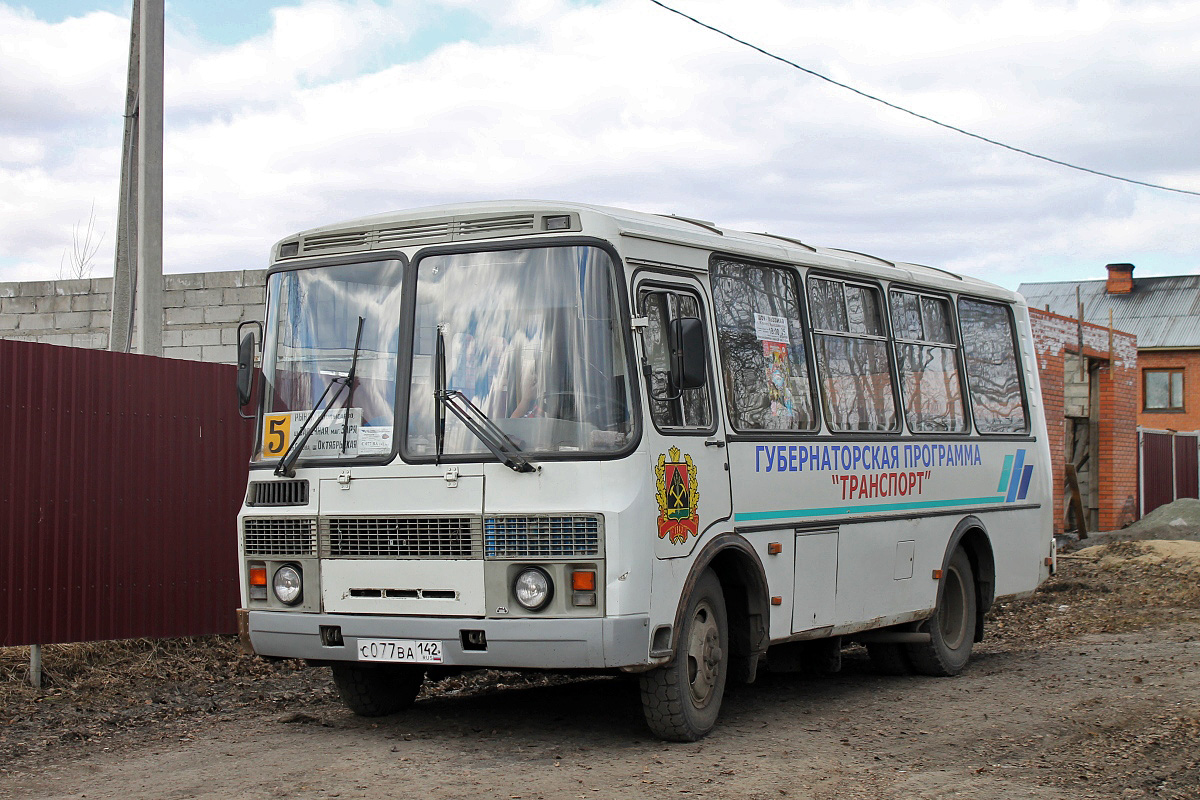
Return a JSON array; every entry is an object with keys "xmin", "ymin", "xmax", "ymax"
[{"xmin": 407, "ymin": 246, "xmax": 635, "ymax": 458}]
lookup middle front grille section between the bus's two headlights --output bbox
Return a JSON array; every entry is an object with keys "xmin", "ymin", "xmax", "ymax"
[{"xmin": 320, "ymin": 517, "xmax": 481, "ymax": 559}]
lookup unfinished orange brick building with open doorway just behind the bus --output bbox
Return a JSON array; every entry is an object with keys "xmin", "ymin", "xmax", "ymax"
[{"xmin": 1030, "ymin": 308, "xmax": 1139, "ymax": 534}]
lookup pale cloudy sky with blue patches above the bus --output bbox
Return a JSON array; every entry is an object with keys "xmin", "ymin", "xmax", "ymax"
[{"xmin": 0, "ymin": 0, "xmax": 1200, "ymax": 288}]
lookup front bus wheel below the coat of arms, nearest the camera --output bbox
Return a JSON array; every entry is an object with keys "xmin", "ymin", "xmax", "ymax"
[{"xmin": 641, "ymin": 570, "xmax": 730, "ymax": 741}]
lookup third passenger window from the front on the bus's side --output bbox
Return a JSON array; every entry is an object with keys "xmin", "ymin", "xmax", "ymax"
[{"xmin": 890, "ymin": 289, "xmax": 966, "ymax": 433}]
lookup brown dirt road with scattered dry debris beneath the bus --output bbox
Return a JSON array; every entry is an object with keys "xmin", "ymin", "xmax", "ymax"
[{"xmin": 0, "ymin": 543, "xmax": 1200, "ymax": 800}]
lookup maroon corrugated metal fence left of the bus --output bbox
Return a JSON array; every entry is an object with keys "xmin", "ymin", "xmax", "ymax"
[{"xmin": 0, "ymin": 341, "xmax": 251, "ymax": 645}]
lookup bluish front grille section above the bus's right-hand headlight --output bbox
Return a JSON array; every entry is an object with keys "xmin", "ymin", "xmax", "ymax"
[{"xmin": 484, "ymin": 515, "xmax": 601, "ymax": 559}]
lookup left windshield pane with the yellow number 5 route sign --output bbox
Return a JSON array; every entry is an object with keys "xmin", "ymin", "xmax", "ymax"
[{"xmin": 256, "ymin": 260, "xmax": 403, "ymax": 459}]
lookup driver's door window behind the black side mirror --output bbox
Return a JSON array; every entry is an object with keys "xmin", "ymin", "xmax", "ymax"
[{"xmin": 642, "ymin": 290, "xmax": 713, "ymax": 431}]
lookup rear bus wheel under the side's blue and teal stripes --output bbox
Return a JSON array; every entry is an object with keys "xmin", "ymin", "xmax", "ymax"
[{"xmin": 906, "ymin": 548, "xmax": 976, "ymax": 676}]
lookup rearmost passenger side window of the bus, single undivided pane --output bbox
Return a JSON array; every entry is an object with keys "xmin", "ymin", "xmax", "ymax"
[{"xmin": 959, "ymin": 297, "xmax": 1028, "ymax": 433}]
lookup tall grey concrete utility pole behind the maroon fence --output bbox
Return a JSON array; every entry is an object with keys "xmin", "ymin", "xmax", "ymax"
[{"xmin": 109, "ymin": 0, "xmax": 163, "ymax": 356}]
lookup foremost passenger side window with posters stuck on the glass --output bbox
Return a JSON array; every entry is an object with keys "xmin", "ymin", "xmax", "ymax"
[{"xmin": 712, "ymin": 260, "xmax": 817, "ymax": 431}]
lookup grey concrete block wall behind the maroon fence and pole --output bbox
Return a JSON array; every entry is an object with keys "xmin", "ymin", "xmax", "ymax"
[{"xmin": 0, "ymin": 270, "xmax": 266, "ymax": 363}]
